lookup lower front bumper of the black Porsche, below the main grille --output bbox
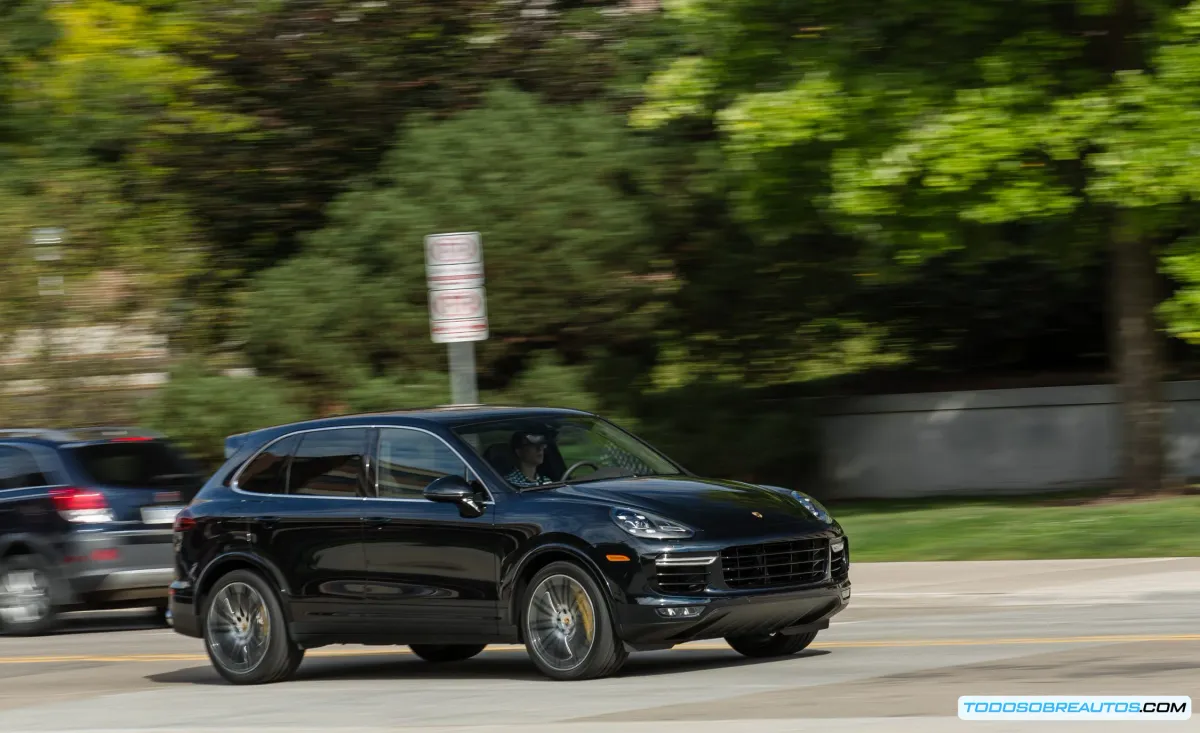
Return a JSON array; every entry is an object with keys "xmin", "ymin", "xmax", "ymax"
[{"xmin": 617, "ymin": 579, "xmax": 851, "ymax": 650}]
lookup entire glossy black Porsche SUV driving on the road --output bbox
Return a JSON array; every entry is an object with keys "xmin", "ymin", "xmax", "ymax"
[{"xmin": 169, "ymin": 407, "xmax": 851, "ymax": 684}]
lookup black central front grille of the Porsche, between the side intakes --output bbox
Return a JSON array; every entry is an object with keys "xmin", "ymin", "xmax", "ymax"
[{"xmin": 721, "ymin": 537, "xmax": 829, "ymax": 589}]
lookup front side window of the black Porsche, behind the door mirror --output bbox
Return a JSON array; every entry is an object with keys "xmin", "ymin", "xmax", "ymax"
[{"xmin": 379, "ymin": 428, "xmax": 467, "ymax": 499}]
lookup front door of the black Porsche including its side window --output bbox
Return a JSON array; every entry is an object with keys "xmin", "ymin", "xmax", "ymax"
[{"xmin": 364, "ymin": 428, "xmax": 503, "ymax": 638}]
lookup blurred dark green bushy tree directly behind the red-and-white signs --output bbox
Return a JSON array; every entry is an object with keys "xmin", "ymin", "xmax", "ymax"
[{"xmin": 241, "ymin": 88, "xmax": 661, "ymax": 410}]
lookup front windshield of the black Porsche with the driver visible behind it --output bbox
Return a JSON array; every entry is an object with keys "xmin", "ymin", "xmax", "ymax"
[{"xmin": 455, "ymin": 416, "xmax": 683, "ymax": 488}]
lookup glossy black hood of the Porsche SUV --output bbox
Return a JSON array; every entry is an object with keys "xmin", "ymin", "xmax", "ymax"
[{"xmin": 557, "ymin": 476, "xmax": 829, "ymax": 540}]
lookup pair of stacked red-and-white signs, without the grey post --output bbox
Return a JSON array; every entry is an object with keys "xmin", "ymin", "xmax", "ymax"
[{"xmin": 425, "ymin": 232, "xmax": 487, "ymax": 343}]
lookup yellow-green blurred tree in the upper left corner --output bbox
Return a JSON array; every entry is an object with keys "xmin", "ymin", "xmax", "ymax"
[{"xmin": 0, "ymin": 0, "xmax": 246, "ymax": 347}]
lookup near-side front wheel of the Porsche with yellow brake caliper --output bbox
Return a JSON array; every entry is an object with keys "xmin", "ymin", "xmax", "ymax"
[{"xmin": 521, "ymin": 561, "xmax": 629, "ymax": 680}]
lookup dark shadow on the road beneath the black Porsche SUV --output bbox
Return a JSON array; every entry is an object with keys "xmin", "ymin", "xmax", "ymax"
[{"xmin": 145, "ymin": 650, "xmax": 829, "ymax": 685}]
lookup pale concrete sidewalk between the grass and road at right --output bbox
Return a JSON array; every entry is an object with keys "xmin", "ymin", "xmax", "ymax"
[{"xmin": 850, "ymin": 558, "xmax": 1200, "ymax": 608}]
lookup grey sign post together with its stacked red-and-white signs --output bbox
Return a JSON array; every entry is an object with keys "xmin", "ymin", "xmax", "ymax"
[{"xmin": 425, "ymin": 232, "xmax": 487, "ymax": 404}]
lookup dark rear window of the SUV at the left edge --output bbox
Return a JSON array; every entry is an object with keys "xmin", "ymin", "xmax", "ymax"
[{"xmin": 70, "ymin": 440, "xmax": 197, "ymax": 488}]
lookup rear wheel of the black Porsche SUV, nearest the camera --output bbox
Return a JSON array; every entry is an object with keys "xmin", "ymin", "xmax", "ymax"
[{"xmin": 200, "ymin": 570, "xmax": 304, "ymax": 685}]
